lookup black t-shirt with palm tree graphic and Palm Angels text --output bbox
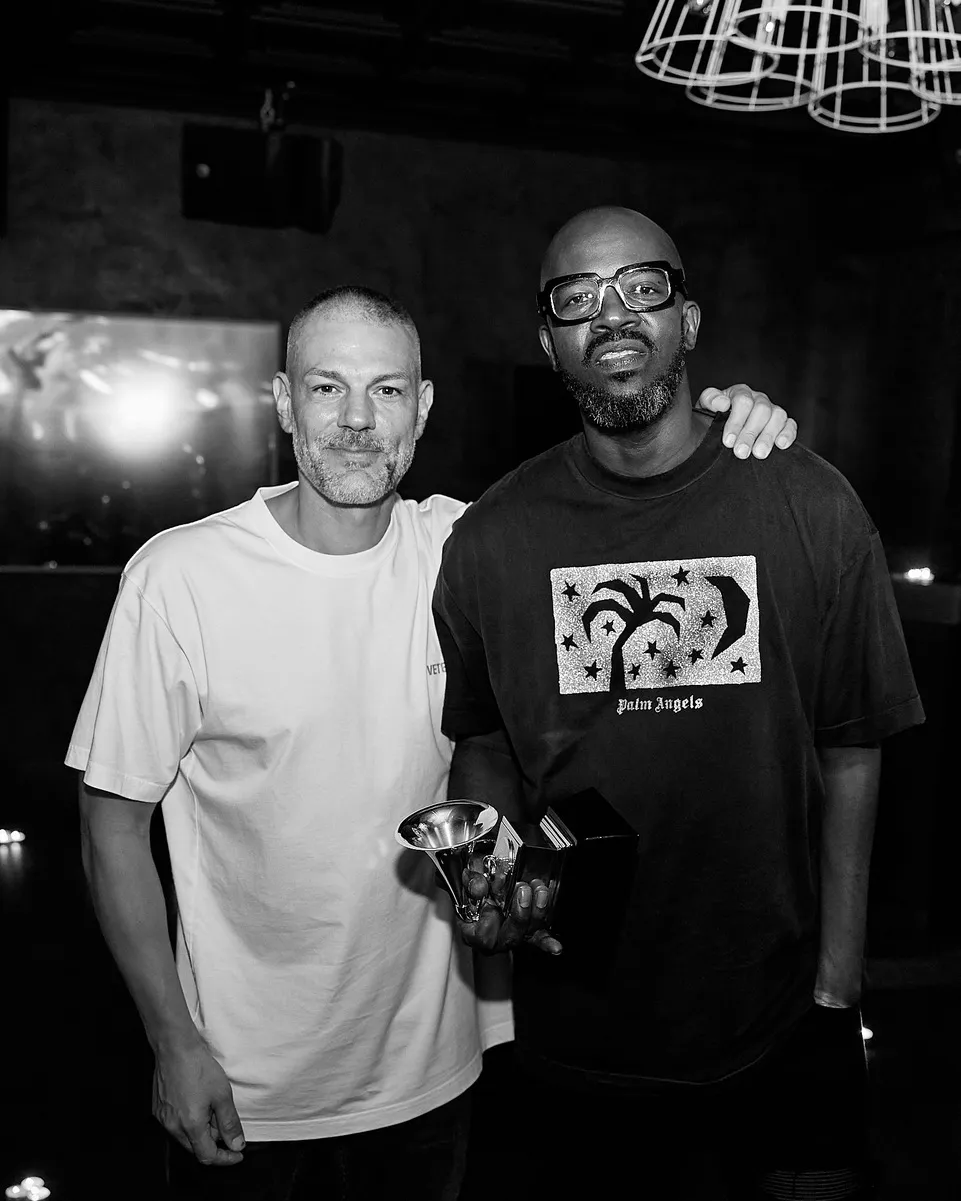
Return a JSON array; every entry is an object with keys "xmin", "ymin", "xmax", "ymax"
[{"xmin": 434, "ymin": 420, "xmax": 924, "ymax": 1083}]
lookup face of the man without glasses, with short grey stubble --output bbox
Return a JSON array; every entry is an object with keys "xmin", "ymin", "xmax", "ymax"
[{"xmin": 274, "ymin": 309, "xmax": 434, "ymax": 507}]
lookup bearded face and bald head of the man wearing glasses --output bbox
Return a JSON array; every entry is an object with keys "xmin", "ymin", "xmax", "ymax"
[{"xmin": 541, "ymin": 209, "xmax": 700, "ymax": 434}]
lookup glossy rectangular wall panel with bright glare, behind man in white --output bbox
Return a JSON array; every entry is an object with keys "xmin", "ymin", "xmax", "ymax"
[{"xmin": 0, "ymin": 310, "xmax": 280, "ymax": 567}]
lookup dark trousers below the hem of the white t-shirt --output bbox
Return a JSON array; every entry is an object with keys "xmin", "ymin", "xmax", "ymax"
[{"xmin": 167, "ymin": 1092, "xmax": 471, "ymax": 1201}]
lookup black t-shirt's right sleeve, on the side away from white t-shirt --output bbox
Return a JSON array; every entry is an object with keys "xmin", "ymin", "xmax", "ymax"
[{"xmin": 814, "ymin": 532, "xmax": 924, "ymax": 747}]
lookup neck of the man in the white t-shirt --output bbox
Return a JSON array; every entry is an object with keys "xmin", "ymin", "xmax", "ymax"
[{"xmin": 267, "ymin": 472, "xmax": 396, "ymax": 555}]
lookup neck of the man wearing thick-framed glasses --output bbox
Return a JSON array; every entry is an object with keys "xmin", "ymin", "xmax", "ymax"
[{"xmin": 584, "ymin": 375, "xmax": 711, "ymax": 478}]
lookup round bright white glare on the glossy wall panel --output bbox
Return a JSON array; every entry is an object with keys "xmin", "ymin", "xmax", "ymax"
[{"xmin": 89, "ymin": 366, "xmax": 189, "ymax": 454}]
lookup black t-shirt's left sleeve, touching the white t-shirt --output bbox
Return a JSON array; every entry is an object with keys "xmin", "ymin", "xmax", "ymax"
[{"xmin": 434, "ymin": 531, "xmax": 502, "ymax": 740}]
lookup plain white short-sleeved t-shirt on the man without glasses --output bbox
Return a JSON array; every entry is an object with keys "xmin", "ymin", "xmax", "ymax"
[{"xmin": 66, "ymin": 485, "xmax": 512, "ymax": 1140}]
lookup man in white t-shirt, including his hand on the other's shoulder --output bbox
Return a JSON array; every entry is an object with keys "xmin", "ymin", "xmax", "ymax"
[{"xmin": 66, "ymin": 288, "xmax": 795, "ymax": 1201}]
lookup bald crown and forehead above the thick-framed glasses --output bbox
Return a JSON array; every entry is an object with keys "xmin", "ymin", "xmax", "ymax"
[{"xmin": 541, "ymin": 205, "xmax": 684, "ymax": 287}]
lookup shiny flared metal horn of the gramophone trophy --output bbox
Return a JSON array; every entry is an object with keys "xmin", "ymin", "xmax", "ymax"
[{"xmin": 394, "ymin": 801, "xmax": 497, "ymax": 921}]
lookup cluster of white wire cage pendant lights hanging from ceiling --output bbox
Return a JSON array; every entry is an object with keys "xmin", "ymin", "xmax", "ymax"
[{"xmin": 635, "ymin": 0, "xmax": 961, "ymax": 133}]
